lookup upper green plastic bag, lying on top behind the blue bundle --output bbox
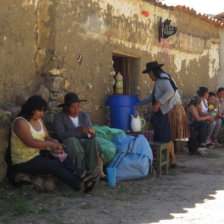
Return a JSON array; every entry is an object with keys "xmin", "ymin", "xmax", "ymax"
[{"xmin": 93, "ymin": 125, "xmax": 125, "ymax": 141}]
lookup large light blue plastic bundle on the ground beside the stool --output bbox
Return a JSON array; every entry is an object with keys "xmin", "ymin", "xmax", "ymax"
[{"xmin": 108, "ymin": 134, "xmax": 153, "ymax": 180}]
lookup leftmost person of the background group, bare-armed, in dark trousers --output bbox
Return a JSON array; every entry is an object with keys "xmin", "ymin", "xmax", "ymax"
[{"xmin": 187, "ymin": 96, "xmax": 212, "ymax": 154}]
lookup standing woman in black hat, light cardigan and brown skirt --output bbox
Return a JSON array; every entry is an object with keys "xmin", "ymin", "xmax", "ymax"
[{"xmin": 141, "ymin": 61, "xmax": 190, "ymax": 168}]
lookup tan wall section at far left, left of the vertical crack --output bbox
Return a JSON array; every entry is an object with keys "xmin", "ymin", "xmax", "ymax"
[{"xmin": 0, "ymin": 0, "xmax": 39, "ymax": 106}]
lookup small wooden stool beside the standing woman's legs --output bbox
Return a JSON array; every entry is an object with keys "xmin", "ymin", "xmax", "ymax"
[{"xmin": 149, "ymin": 141, "xmax": 169, "ymax": 177}]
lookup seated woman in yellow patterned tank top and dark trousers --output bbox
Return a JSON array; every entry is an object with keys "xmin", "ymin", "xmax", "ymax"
[{"xmin": 11, "ymin": 96, "xmax": 99, "ymax": 192}]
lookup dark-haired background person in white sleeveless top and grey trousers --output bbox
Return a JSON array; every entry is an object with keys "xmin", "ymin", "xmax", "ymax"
[{"xmin": 197, "ymin": 87, "xmax": 222, "ymax": 146}]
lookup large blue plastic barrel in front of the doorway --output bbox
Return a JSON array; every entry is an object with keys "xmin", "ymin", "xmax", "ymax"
[{"xmin": 105, "ymin": 95, "xmax": 140, "ymax": 131}]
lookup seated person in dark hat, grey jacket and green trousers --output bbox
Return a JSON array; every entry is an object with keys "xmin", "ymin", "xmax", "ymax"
[{"xmin": 53, "ymin": 93, "xmax": 105, "ymax": 178}]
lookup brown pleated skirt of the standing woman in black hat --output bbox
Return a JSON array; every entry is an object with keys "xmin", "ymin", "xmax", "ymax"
[{"xmin": 168, "ymin": 103, "xmax": 190, "ymax": 140}]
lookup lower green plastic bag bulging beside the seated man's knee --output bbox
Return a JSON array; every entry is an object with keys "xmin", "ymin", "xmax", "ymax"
[{"xmin": 96, "ymin": 137, "xmax": 117, "ymax": 165}]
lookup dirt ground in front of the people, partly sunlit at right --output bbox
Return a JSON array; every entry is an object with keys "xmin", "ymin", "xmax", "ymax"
[{"xmin": 0, "ymin": 148, "xmax": 224, "ymax": 224}]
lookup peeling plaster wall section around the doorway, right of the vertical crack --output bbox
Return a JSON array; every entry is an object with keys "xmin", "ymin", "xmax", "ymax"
[{"xmin": 50, "ymin": 0, "xmax": 220, "ymax": 124}]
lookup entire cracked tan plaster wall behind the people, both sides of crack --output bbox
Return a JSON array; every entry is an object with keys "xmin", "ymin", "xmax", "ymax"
[{"xmin": 0, "ymin": 0, "xmax": 220, "ymax": 124}]
